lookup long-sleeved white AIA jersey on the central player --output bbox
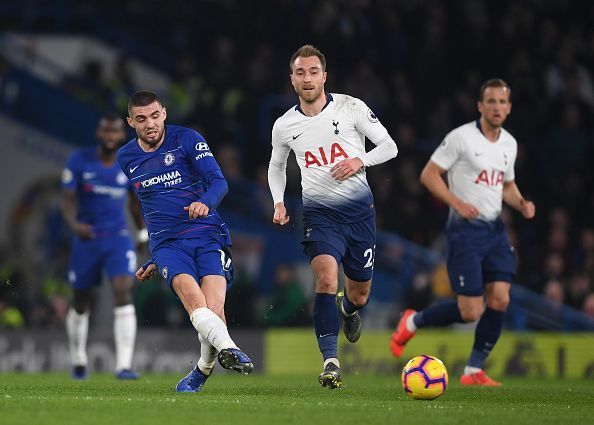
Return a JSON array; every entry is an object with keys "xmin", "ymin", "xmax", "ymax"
[{"xmin": 271, "ymin": 93, "xmax": 393, "ymax": 222}]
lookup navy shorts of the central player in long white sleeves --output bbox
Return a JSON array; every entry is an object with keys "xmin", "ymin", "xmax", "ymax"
[{"xmin": 301, "ymin": 214, "xmax": 375, "ymax": 282}]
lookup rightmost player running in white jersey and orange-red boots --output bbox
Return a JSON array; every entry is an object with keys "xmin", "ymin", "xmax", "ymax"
[{"xmin": 391, "ymin": 79, "xmax": 535, "ymax": 386}]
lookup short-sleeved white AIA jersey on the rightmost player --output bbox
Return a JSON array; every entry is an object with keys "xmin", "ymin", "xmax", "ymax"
[{"xmin": 431, "ymin": 121, "xmax": 518, "ymax": 221}]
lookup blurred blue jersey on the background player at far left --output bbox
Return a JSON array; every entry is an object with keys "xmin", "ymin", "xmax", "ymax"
[{"xmin": 62, "ymin": 147, "xmax": 130, "ymax": 238}]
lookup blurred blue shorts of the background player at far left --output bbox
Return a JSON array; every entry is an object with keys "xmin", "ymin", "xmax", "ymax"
[{"xmin": 68, "ymin": 235, "xmax": 137, "ymax": 290}]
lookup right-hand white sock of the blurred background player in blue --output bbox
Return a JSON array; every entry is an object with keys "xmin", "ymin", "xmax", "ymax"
[{"xmin": 113, "ymin": 304, "xmax": 136, "ymax": 372}]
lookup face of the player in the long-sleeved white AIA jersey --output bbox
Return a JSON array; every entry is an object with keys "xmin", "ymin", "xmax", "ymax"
[{"xmin": 291, "ymin": 56, "xmax": 326, "ymax": 103}]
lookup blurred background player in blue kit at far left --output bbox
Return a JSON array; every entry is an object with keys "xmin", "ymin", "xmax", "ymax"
[{"xmin": 62, "ymin": 114, "xmax": 148, "ymax": 379}]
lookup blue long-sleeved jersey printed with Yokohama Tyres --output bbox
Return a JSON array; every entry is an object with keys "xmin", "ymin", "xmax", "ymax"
[{"xmin": 117, "ymin": 125, "xmax": 231, "ymax": 251}]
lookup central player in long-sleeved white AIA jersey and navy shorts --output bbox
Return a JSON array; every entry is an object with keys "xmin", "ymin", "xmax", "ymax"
[{"xmin": 268, "ymin": 45, "xmax": 398, "ymax": 388}]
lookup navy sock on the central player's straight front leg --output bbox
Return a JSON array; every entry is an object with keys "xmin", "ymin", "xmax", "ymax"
[{"xmin": 313, "ymin": 293, "xmax": 340, "ymax": 360}]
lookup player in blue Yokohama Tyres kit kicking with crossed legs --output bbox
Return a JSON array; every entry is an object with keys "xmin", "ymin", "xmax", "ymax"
[{"xmin": 117, "ymin": 91, "xmax": 253, "ymax": 392}]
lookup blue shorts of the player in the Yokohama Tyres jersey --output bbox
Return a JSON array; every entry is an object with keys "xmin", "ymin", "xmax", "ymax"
[{"xmin": 153, "ymin": 238, "xmax": 233, "ymax": 289}]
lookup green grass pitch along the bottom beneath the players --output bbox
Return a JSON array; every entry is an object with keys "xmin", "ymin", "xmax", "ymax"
[{"xmin": 0, "ymin": 373, "xmax": 594, "ymax": 425}]
